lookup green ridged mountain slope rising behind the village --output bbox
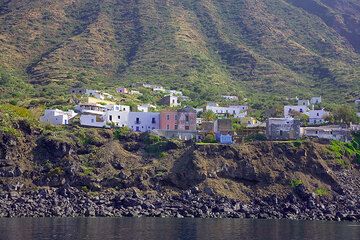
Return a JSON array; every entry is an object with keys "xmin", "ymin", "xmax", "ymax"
[{"xmin": 0, "ymin": 0, "xmax": 360, "ymax": 104}]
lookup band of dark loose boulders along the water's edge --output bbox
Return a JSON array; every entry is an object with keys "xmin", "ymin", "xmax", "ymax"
[{"xmin": 0, "ymin": 186, "xmax": 360, "ymax": 221}]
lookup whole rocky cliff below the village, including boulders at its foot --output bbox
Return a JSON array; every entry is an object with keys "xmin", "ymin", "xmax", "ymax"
[{"xmin": 0, "ymin": 122, "xmax": 360, "ymax": 220}]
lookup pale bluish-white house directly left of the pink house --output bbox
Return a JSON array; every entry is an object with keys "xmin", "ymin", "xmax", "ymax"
[{"xmin": 128, "ymin": 112, "xmax": 160, "ymax": 132}]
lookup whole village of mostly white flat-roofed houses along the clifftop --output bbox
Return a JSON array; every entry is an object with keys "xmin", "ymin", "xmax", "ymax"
[{"xmin": 40, "ymin": 84, "xmax": 360, "ymax": 144}]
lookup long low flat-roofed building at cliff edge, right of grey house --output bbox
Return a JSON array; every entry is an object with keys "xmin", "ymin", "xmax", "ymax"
[{"xmin": 302, "ymin": 126, "xmax": 352, "ymax": 142}]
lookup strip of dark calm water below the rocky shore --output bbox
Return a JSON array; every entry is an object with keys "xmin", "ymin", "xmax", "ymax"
[{"xmin": 0, "ymin": 218, "xmax": 360, "ymax": 240}]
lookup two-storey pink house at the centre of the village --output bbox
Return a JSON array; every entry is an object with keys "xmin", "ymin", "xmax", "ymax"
[{"xmin": 160, "ymin": 107, "xmax": 196, "ymax": 131}]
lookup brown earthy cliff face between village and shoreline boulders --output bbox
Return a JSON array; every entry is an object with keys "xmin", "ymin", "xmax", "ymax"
[{"xmin": 0, "ymin": 122, "xmax": 359, "ymax": 201}]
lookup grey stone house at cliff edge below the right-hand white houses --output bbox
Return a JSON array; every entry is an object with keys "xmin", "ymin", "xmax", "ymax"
[{"xmin": 266, "ymin": 118, "xmax": 301, "ymax": 140}]
